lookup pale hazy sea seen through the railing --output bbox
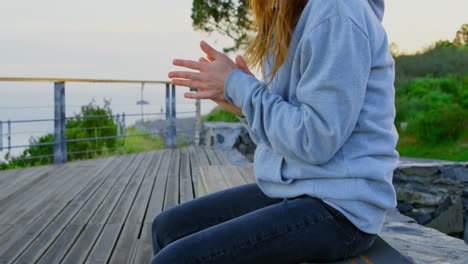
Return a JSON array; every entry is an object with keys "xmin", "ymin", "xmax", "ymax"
[{"xmin": 0, "ymin": 82, "xmax": 216, "ymax": 161}]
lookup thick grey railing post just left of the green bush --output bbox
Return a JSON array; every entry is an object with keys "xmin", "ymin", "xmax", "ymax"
[{"xmin": 54, "ymin": 82, "xmax": 67, "ymax": 164}]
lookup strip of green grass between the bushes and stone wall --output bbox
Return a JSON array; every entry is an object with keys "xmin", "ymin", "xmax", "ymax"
[{"xmin": 397, "ymin": 132, "xmax": 468, "ymax": 161}]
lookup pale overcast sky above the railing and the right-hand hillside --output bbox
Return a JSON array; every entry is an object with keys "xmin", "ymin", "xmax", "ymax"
[{"xmin": 0, "ymin": 0, "xmax": 468, "ymax": 80}]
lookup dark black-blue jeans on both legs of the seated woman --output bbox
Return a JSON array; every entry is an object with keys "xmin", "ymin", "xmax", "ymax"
[{"xmin": 151, "ymin": 183, "xmax": 376, "ymax": 264}]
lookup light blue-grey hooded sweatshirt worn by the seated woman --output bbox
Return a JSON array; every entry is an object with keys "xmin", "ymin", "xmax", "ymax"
[{"xmin": 225, "ymin": 0, "xmax": 399, "ymax": 234}]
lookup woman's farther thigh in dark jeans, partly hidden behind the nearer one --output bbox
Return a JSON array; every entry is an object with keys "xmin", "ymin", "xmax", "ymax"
[{"xmin": 152, "ymin": 183, "xmax": 283, "ymax": 254}]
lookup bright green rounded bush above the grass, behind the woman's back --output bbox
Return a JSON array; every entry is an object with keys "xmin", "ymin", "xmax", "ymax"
[{"xmin": 395, "ymin": 77, "xmax": 468, "ymax": 144}]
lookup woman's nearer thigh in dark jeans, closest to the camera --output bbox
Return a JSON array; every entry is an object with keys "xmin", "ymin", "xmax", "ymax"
[{"xmin": 152, "ymin": 197, "xmax": 368, "ymax": 264}]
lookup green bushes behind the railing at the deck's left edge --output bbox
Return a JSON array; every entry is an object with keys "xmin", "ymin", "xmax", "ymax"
[{"xmin": 0, "ymin": 100, "xmax": 122, "ymax": 169}]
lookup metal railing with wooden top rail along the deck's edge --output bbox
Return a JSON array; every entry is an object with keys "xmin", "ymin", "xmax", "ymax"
[{"xmin": 0, "ymin": 77, "xmax": 201, "ymax": 164}]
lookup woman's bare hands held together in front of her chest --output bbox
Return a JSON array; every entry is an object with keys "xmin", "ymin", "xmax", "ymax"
[{"xmin": 168, "ymin": 41, "xmax": 253, "ymax": 117}]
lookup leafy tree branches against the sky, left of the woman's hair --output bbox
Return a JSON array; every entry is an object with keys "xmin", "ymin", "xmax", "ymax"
[{"xmin": 192, "ymin": 0, "xmax": 254, "ymax": 52}]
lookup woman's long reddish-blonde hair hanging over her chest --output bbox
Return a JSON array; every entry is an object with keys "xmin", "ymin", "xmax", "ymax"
[{"xmin": 246, "ymin": 0, "xmax": 308, "ymax": 80}]
